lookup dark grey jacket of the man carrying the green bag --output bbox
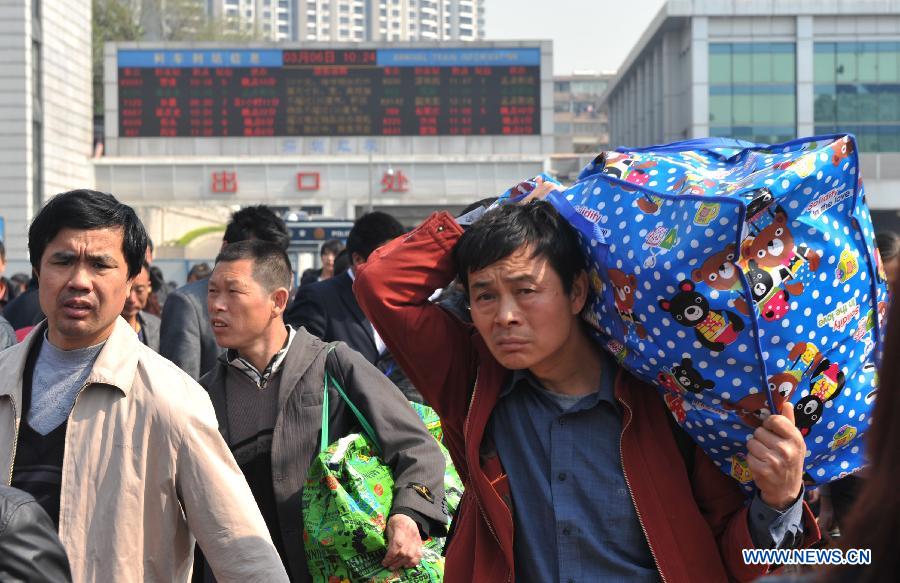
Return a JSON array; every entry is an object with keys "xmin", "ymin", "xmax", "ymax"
[{"xmin": 200, "ymin": 330, "xmax": 447, "ymax": 582}]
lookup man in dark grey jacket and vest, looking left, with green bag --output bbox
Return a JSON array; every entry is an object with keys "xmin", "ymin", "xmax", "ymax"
[{"xmin": 200, "ymin": 241, "xmax": 447, "ymax": 581}]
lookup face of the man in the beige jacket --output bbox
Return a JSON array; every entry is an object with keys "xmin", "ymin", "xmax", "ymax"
[{"xmin": 38, "ymin": 228, "xmax": 132, "ymax": 350}]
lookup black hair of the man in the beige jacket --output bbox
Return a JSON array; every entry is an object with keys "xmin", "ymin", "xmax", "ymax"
[{"xmin": 28, "ymin": 189, "xmax": 148, "ymax": 279}]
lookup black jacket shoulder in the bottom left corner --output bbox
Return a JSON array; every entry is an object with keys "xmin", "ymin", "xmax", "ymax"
[{"xmin": 0, "ymin": 485, "xmax": 72, "ymax": 583}]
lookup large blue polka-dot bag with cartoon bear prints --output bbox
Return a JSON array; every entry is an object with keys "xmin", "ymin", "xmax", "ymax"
[{"xmin": 549, "ymin": 135, "xmax": 887, "ymax": 492}]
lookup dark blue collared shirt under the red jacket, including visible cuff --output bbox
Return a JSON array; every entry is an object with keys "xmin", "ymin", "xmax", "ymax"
[{"xmin": 488, "ymin": 355, "xmax": 802, "ymax": 583}]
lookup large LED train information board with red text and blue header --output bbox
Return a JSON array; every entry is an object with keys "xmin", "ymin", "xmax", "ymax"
[{"xmin": 117, "ymin": 48, "xmax": 541, "ymax": 138}]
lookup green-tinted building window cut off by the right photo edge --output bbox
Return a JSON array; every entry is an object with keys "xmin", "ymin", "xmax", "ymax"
[{"xmin": 813, "ymin": 42, "xmax": 900, "ymax": 152}]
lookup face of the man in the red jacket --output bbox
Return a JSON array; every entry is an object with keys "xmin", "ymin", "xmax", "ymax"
[{"xmin": 469, "ymin": 247, "xmax": 586, "ymax": 370}]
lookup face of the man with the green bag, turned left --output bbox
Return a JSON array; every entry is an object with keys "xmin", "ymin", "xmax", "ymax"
[{"xmin": 206, "ymin": 259, "xmax": 275, "ymax": 352}]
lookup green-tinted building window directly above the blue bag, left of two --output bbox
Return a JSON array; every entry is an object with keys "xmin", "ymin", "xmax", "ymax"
[{"xmin": 709, "ymin": 43, "xmax": 797, "ymax": 143}]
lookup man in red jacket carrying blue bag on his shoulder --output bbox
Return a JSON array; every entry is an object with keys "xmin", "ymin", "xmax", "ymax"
[{"xmin": 354, "ymin": 186, "xmax": 818, "ymax": 582}]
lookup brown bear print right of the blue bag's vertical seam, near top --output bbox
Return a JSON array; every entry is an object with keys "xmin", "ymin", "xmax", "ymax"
[{"xmin": 741, "ymin": 206, "xmax": 821, "ymax": 296}]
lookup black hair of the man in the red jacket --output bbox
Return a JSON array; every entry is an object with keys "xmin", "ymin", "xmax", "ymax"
[{"xmin": 453, "ymin": 200, "xmax": 586, "ymax": 296}]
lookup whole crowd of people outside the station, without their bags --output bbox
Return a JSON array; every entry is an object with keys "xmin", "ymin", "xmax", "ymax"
[{"xmin": 0, "ymin": 185, "xmax": 900, "ymax": 583}]
